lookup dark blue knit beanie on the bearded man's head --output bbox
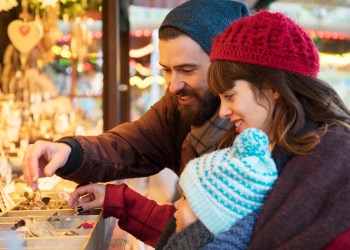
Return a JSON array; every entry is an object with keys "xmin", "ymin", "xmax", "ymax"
[{"xmin": 160, "ymin": 0, "xmax": 250, "ymax": 54}]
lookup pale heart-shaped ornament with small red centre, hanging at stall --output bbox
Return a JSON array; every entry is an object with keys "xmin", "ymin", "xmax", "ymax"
[{"xmin": 7, "ymin": 20, "xmax": 43, "ymax": 54}]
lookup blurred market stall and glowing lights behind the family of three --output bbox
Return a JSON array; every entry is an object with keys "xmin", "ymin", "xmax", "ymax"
[{"xmin": 0, "ymin": 0, "xmax": 350, "ymax": 249}]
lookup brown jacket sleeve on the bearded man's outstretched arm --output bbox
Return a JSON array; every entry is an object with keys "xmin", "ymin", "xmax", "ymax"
[{"xmin": 56, "ymin": 92, "xmax": 190, "ymax": 183}]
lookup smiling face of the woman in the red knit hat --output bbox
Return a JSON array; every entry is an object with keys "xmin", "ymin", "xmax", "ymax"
[{"xmin": 219, "ymin": 80, "xmax": 280, "ymax": 138}]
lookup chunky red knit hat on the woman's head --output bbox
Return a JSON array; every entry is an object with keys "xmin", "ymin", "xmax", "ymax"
[{"xmin": 210, "ymin": 10, "xmax": 320, "ymax": 76}]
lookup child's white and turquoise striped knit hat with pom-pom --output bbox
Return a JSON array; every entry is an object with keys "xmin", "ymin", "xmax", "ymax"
[{"xmin": 179, "ymin": 128, "xmax": 277, "ymax": 235}]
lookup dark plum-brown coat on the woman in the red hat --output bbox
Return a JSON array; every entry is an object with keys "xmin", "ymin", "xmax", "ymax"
[{"xmin": 248, "ymin": 126, "xmax": 350, "ymax": 250}]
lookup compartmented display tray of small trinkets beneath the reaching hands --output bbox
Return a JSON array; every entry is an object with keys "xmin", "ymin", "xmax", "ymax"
[{"xmin": 0, "ymin": 205, "xmax": 110, "ymax": 250}]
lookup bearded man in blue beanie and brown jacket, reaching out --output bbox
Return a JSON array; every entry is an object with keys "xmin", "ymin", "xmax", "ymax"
[{"xmin": 23, "ymin": 0, "xmax": 249, "ymax": 190}]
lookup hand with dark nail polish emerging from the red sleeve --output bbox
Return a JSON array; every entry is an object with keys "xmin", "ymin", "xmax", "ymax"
[{"xmin": 68, "ymin": 183, "xmax": 106, "ymax": 212}]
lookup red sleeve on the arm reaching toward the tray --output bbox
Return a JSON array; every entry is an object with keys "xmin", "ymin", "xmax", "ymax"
[{"xmin": 103, "ymin": 184, "xmax": 175, "ymax": 247}]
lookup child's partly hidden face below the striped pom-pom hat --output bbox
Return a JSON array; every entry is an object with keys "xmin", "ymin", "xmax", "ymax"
[{"xmin": 174, "ymin": 197, "xmax": 197, "ymax": 233}]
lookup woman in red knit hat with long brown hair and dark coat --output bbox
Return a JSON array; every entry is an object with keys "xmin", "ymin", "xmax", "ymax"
[{"xmin": 204, "ymin": 11, "xmax": 350, "ymax": 249}]
